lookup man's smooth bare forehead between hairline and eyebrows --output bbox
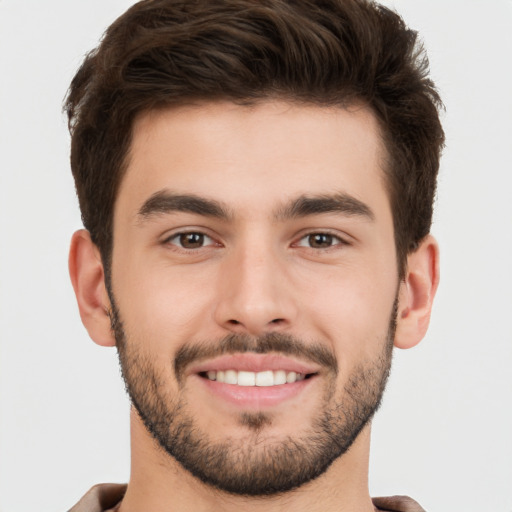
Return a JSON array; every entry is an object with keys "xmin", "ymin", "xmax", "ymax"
[{"xmin": 116, "ymin": 101, "xmax": 389, "ymax": 220}]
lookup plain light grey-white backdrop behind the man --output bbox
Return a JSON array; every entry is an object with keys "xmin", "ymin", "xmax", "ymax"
[{"xmin": 0, "ymin": 0, "xmax": 512, "ymax": 512}]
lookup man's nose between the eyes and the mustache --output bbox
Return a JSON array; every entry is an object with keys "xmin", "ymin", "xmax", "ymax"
[{"xmin": 215, "ymin": 240, "xmax": 297, "ymax": 336}]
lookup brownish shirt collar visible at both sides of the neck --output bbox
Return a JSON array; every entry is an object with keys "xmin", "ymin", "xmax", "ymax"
[{"xmin": 68, "ymin": 484, "xmax": 425, "ymax": 512}]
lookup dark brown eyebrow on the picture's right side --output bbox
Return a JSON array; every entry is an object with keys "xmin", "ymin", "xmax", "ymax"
[{"xmin": 276, "ymin": 193, "xmax": 375, "ymax": 221}]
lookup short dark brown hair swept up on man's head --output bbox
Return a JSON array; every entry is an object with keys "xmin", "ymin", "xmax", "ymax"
[{"xmin": 65, "ymin": 0, "xmax": 444, "ymax": 275}]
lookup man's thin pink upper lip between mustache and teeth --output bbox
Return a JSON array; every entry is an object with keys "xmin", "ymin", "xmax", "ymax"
[{"xmin": 187, "ymin": 352, "xmax": 320, "ymax": 375}]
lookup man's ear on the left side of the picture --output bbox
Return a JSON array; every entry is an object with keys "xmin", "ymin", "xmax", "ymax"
[{"xmin": 69, "ymin": 229, "xmax": 116, "ymax": 347}]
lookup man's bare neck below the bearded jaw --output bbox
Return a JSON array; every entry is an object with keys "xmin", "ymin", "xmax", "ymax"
[{"xmin": 119, "ymin": 410, "xmax": 374, "ymax": 512}]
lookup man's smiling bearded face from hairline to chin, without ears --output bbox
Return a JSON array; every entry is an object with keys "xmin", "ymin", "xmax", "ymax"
[{"xmin": 110, "ymin": 102, "xmax": 398, "ymax": 495}]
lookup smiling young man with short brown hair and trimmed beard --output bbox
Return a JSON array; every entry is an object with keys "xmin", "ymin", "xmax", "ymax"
[{"xmin": 66, "ymin": 0, "xmax": 444, "ymax": 512}]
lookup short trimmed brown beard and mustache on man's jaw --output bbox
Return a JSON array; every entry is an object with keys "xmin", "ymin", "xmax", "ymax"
[{"xmin": 111, "ymin": 294, "xmax": 398, "ymax": 496}]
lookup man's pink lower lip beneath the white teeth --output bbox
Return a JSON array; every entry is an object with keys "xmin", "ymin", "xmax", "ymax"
[{"xmin": 197, "ymin": 376, "xmax": 316, "ymax": 409}]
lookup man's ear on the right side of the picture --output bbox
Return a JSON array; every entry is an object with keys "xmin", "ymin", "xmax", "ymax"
[{"xmin": 395, "ymin": 235, "xmax": 439, "ymax": 348}]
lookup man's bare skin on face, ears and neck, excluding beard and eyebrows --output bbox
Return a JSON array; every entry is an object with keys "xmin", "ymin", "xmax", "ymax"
[{"xmin": 70, "ymin": 101, "xmax": 439, "ymax": 512}]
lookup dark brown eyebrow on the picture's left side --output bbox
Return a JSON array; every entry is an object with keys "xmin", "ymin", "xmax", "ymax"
[{"xmin": 137, "ymin": 190, "xmax": 232, "ymax": 220}]
